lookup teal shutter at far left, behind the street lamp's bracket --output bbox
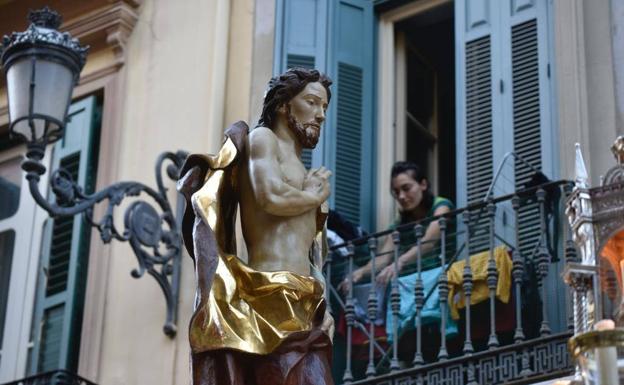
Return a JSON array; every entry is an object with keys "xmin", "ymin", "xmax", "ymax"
[{"xmin": 29, "ymin": 97, "xmax": 98, "ymax": 374}]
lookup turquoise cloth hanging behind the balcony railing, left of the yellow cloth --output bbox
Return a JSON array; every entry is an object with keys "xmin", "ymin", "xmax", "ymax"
[{"xmin": 386, "ymin": 266, "xmax": 457, "ymax": 341}]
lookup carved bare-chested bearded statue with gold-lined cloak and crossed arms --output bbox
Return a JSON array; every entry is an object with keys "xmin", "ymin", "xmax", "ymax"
[{"xmin": 178, "ymin": 68, "xmax": 333, "ymax": 385}]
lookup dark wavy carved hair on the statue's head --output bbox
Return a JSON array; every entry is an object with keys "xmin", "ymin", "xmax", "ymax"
[{"xmin": 258, "ymin": 67, "xmax": 332, "ymax": 129}]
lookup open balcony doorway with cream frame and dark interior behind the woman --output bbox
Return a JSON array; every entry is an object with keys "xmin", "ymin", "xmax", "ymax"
[{"xmin": 376, "ymin": 0, "xmax": 457, "ymax": 229}]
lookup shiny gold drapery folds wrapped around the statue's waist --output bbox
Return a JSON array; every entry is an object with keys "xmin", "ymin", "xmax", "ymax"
[{"xmin": 189, "ymin": 255, "xmax": 325, "ymax": 354}]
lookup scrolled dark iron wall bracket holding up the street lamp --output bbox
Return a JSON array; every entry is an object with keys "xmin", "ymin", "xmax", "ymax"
[{"xmin": 22, "ymin": 148, "xmax": 187, "ymax": 337}]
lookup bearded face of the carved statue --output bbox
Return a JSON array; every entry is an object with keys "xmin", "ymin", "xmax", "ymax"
[{"xmin": 286, "ymin": 82, "xmax": 327, "ymax": 148}]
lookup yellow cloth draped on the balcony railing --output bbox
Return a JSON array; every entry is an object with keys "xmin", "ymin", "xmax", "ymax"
[{"xmin": 447, "ymin": 246, "xmax": 512, "ymax": 319}]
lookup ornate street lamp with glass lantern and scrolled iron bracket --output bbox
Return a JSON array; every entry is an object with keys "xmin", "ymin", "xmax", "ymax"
[{"xmin": 0, "ymin": 7, "xmax": 186, "ymax": 337}]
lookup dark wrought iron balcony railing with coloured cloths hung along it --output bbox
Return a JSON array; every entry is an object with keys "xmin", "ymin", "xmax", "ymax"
[{"xmin": 324, "ymin": 181, "xmax": 577, "ymax": 385}]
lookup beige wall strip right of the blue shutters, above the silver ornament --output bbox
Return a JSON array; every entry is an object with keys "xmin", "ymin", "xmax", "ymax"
[{"xmin": 554, "ymin": 0, "xmax": 621, "ymax": 185}]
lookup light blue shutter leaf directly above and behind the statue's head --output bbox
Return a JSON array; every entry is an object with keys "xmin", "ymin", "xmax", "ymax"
[{"xmin": 274, "ymin": 0, "xmax": 327, "ymax": 168}]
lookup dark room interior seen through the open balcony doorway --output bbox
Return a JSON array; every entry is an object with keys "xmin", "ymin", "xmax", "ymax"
[{"xmin": 396, "ymin": 3, "xmax": 455, "ymax": 200}]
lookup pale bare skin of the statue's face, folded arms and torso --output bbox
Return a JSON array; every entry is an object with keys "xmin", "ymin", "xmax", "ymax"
[{"xmin": 239, "ymin": 83, "xmax": 331, "ymax": 275}]
